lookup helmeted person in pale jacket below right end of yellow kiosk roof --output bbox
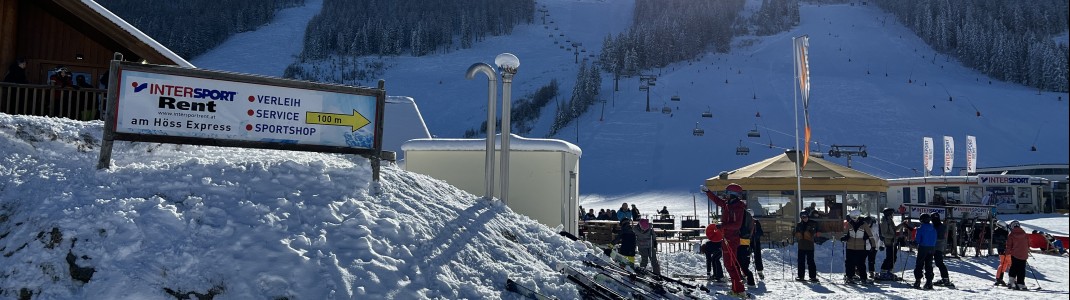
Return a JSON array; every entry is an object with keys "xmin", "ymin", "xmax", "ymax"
[{"xmin": 840, "ymin": 210, "xmax": 878, "ymax": 284}]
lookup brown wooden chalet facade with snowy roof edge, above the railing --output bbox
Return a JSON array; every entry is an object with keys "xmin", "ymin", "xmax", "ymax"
[{"xmin": 0, "ymin": 0, "xmax": 192, "ymax": 87}]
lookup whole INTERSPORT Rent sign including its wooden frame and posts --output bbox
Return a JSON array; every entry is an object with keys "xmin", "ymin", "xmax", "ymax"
[{"xmin": 97, "ymin": 60, "xmax": 392, "ymax": 175}]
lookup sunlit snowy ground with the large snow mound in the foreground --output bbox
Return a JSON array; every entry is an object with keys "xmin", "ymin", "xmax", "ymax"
[{"xmin": 0, "ymin": 115, "xmax": 1070, "ymax": 299}]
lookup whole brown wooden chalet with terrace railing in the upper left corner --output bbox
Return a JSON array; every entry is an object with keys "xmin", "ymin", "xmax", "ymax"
[{"xmin": 0, "ymin": 0, "xmax": 194, "ymax": 120}]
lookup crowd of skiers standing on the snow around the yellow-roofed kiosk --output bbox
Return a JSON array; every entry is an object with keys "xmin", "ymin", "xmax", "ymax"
[{"xmin": 581, "ymin": 183, "xmax": 1029, "ymax": 297}]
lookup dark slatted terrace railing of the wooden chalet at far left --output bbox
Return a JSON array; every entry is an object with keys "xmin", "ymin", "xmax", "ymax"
[{"xmin": 0, "ymin": 83, "xmax": 107, "ymax": 121}]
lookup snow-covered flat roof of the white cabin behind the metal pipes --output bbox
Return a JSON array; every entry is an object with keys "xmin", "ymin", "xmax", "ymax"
[{"xmin": 401, "ymin": 134, "xmax": 583, "ymax": 156}]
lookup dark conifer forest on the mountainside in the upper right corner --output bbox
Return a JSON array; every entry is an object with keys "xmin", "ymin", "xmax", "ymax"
[{"xmin": 875, "ymin": 0, "xmax": 1068, "ymax": 92}]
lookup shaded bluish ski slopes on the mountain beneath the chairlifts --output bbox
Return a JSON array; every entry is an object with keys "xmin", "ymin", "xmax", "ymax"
[{"xmin": 193, "ymin": 0, "xmax": 1070, "ymax": 200}]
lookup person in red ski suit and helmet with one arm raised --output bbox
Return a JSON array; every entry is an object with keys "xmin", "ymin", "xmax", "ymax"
[{"xmin": 699, "ymin": 183, "xmax": 747, "ymax": 297}]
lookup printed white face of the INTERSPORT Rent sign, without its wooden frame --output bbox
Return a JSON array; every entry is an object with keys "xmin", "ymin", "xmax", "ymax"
[{"xmin": 116, "ymin": 70, "xmax": 376, "ymax": 149}]
